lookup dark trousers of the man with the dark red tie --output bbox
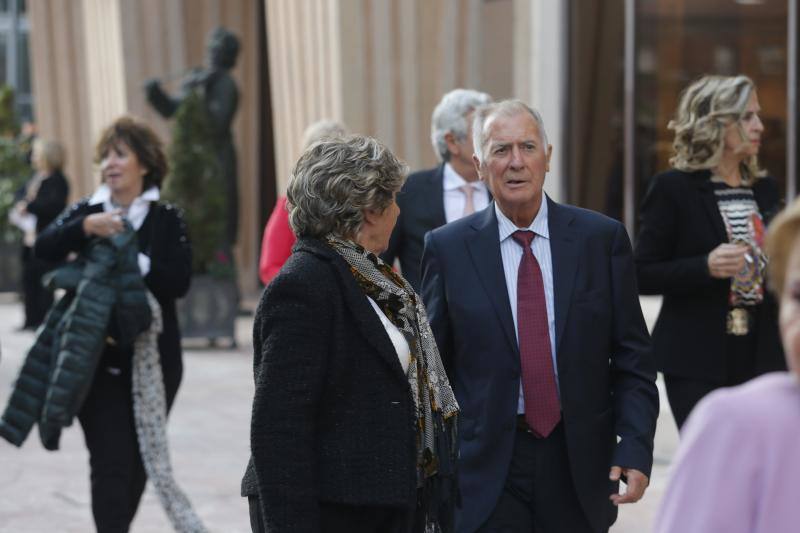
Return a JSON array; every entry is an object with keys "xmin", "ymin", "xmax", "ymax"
[{"xmin": 478, "ymin": 423, "xmax": 596, "ymax": 533}]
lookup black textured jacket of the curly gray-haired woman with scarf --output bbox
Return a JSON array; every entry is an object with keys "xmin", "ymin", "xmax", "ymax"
[{"xmin": 242, "ymin": 239, "xmax": 416, "ymax": 533}]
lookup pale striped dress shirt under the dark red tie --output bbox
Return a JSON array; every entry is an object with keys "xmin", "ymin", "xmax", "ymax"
[{"xmin": 494, "ymin": 195, "xmax": 560, "ymax": 414}]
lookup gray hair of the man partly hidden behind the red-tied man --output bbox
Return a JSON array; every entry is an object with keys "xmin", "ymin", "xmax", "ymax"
[{"xmin": 431, "ymin": 89, "xmax": 492, "ymax": 161}]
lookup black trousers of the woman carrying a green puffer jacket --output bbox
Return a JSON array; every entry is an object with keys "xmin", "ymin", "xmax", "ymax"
[{"xmin": 78, "ymin": 347, "xmax": 179, "ymax": 533}]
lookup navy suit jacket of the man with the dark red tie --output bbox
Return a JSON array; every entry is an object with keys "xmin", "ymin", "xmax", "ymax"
[{"xmin": 422, "ymin": 198, "xmax": 658, "ymax": 533}]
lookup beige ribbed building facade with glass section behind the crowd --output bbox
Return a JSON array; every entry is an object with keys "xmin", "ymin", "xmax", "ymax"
[{"xmin": 27, "ymin": 0, "xmax": 798, "ymax": 295}]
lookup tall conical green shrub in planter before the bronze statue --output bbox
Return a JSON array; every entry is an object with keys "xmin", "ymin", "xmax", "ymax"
[{"xmin": 163, "ymin": 90, "xmax": 228, "ymax": 277}]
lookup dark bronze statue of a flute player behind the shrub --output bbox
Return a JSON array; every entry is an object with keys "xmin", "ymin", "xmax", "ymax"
[{"xmin": 145, "ymin": 27, "xmax": 239, "ymax": 246}]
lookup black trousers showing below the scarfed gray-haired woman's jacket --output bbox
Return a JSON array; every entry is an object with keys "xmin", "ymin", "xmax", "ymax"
[{"xmin": 248, "ymin": 496, "xmax": 412, "ymax": 533}]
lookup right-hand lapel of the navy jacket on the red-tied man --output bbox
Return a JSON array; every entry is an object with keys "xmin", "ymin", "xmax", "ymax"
[{"xmin": 545, "ymin": 196, "xmax": 580, "ymax": 369}]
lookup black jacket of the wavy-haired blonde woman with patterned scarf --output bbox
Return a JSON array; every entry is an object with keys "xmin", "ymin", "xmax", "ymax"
[{"xmin": 636, "ymin": 170, "xmax": 785, "ymax": 383}]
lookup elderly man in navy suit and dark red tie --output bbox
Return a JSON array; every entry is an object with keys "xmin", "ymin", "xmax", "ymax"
[{"xmin": 422, "ymin": 101, "xmax": 658, "ymax": 533}]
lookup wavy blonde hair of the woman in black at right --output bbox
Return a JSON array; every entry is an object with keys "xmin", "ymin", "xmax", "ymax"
[{"xmin": 667, "ymin": 76, "xmax": 765, "ymax": 185}]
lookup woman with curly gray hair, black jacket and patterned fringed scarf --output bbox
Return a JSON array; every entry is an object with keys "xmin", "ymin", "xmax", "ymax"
[{"xmin": 242, "ymin": 136, "xmax": 458, "ymax": 533}]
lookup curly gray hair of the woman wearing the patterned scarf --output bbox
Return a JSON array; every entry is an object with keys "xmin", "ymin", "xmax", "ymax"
[{"xmin": 286, "ymin": 135, "xmax": 408, "ymax": 239}]
